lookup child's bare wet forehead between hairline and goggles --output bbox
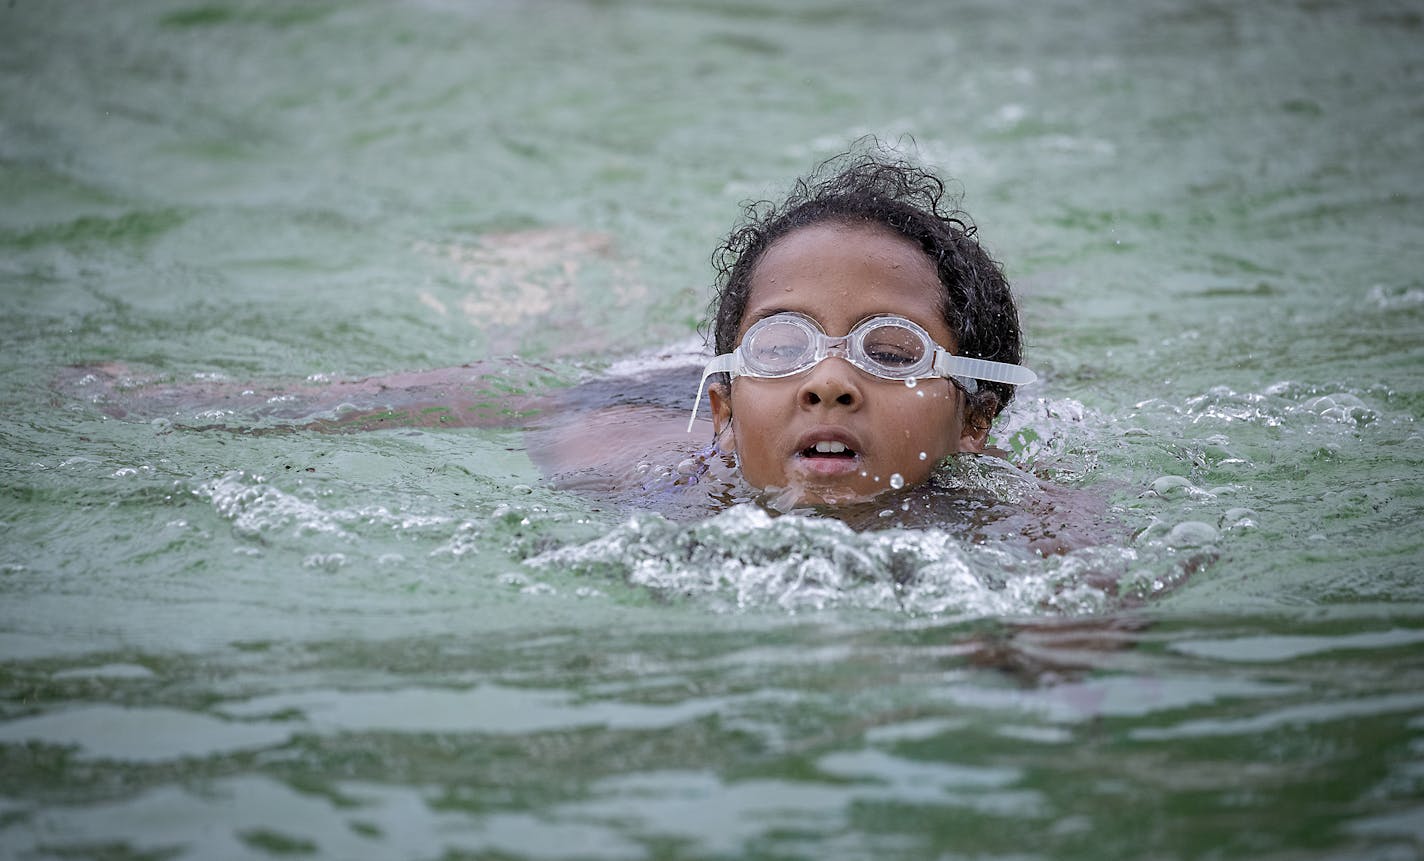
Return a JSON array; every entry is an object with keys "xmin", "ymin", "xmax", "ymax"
[{"xmin": 740, "ymin": 223, "xmax": 948, "ymax": 339}]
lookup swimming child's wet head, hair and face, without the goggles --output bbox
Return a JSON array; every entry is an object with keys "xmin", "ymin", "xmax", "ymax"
[{"xmin": 711, "ymin": 152, "xmax": 1020, "ymax": 504}]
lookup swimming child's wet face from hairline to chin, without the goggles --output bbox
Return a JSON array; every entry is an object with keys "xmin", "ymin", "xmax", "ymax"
[{"xmin": 711, "ymin": 223, "xmax": 988, "ymax": 505}]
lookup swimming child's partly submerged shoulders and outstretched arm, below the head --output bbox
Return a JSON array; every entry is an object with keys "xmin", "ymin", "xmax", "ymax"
[{"xmin": 57, "ymin": 357, "xmax": 1121, "ymax": 554}]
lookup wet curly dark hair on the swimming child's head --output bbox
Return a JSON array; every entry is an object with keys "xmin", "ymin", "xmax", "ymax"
[{"xmin": 709, "ymin": 147, "xmax": 1021, "ymax": 420}]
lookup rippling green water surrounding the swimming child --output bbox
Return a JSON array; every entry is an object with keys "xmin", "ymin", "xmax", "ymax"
[{"xmin": 0, "ymin": 0, "xmax": 1424, "ymax": 861}]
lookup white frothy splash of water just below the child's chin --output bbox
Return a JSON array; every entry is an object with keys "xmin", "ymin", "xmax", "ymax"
[{"xmin": 524, "ymin": 504, "xmax": 1139, "ymax": 616}]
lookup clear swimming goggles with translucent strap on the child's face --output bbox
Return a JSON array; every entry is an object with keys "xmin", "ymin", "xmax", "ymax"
[{"xmin": 688, "ymin": 312, "xmax": 1038, "ymax": 433}]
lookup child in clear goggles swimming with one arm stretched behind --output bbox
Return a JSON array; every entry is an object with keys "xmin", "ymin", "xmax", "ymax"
[{"xmin": 61, "ymin": 149, "xmax": 1101, "ymax": 549}]
